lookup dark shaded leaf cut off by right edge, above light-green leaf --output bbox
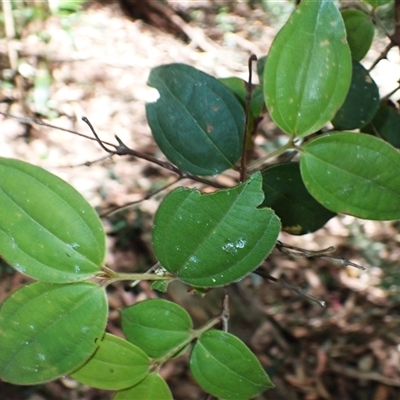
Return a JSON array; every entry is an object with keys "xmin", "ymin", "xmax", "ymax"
[{"xmin": 363, "ymin": 103, "xmax": 400, "ymax": 148}]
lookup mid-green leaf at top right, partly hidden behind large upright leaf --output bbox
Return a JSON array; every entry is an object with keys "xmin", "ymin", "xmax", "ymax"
[{"xmin": 341, "ymin": 9, "xmax": 375, "ymax": 61}]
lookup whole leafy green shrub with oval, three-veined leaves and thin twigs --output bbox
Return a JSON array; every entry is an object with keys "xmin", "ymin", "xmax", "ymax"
[{"xmin": 0, "ymin": 0, "xmax": 400, "ymax": 400}]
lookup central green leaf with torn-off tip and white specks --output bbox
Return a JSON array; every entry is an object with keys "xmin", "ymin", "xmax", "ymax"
[{"xmin": 153, "ymin": 173, "xmax": 280, "ymax": 287}]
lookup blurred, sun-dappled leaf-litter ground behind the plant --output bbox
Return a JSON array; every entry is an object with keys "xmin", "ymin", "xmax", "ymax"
[{"xmin": 0, "ymin": 1, "xmax": 400, "ymax": 400}]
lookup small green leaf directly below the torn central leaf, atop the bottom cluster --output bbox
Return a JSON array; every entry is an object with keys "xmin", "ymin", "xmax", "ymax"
[{"xmin": 121, "ymin": 299, "xmax": 193, "ymax": 358}]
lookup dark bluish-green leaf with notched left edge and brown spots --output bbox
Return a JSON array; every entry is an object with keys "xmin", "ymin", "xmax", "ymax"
[{"xmin": 146, "ymin": 64, "xmax": 245, "ymax": 175}]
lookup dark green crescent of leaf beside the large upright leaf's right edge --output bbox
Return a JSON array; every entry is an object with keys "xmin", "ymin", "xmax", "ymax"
[{"xmin": 332, "ymin": 61, "xmax": 379, "ymax": 130}]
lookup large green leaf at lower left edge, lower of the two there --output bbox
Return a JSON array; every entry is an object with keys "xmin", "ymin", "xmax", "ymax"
[{"xmin": 0, "ymin": 282, "xmax": 108, "ymax": 385}]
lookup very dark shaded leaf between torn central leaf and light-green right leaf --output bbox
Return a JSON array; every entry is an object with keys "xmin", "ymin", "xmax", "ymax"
[{"xmin": 262, "ymin": 162, "xmax": 336, "ymax": 235}]
